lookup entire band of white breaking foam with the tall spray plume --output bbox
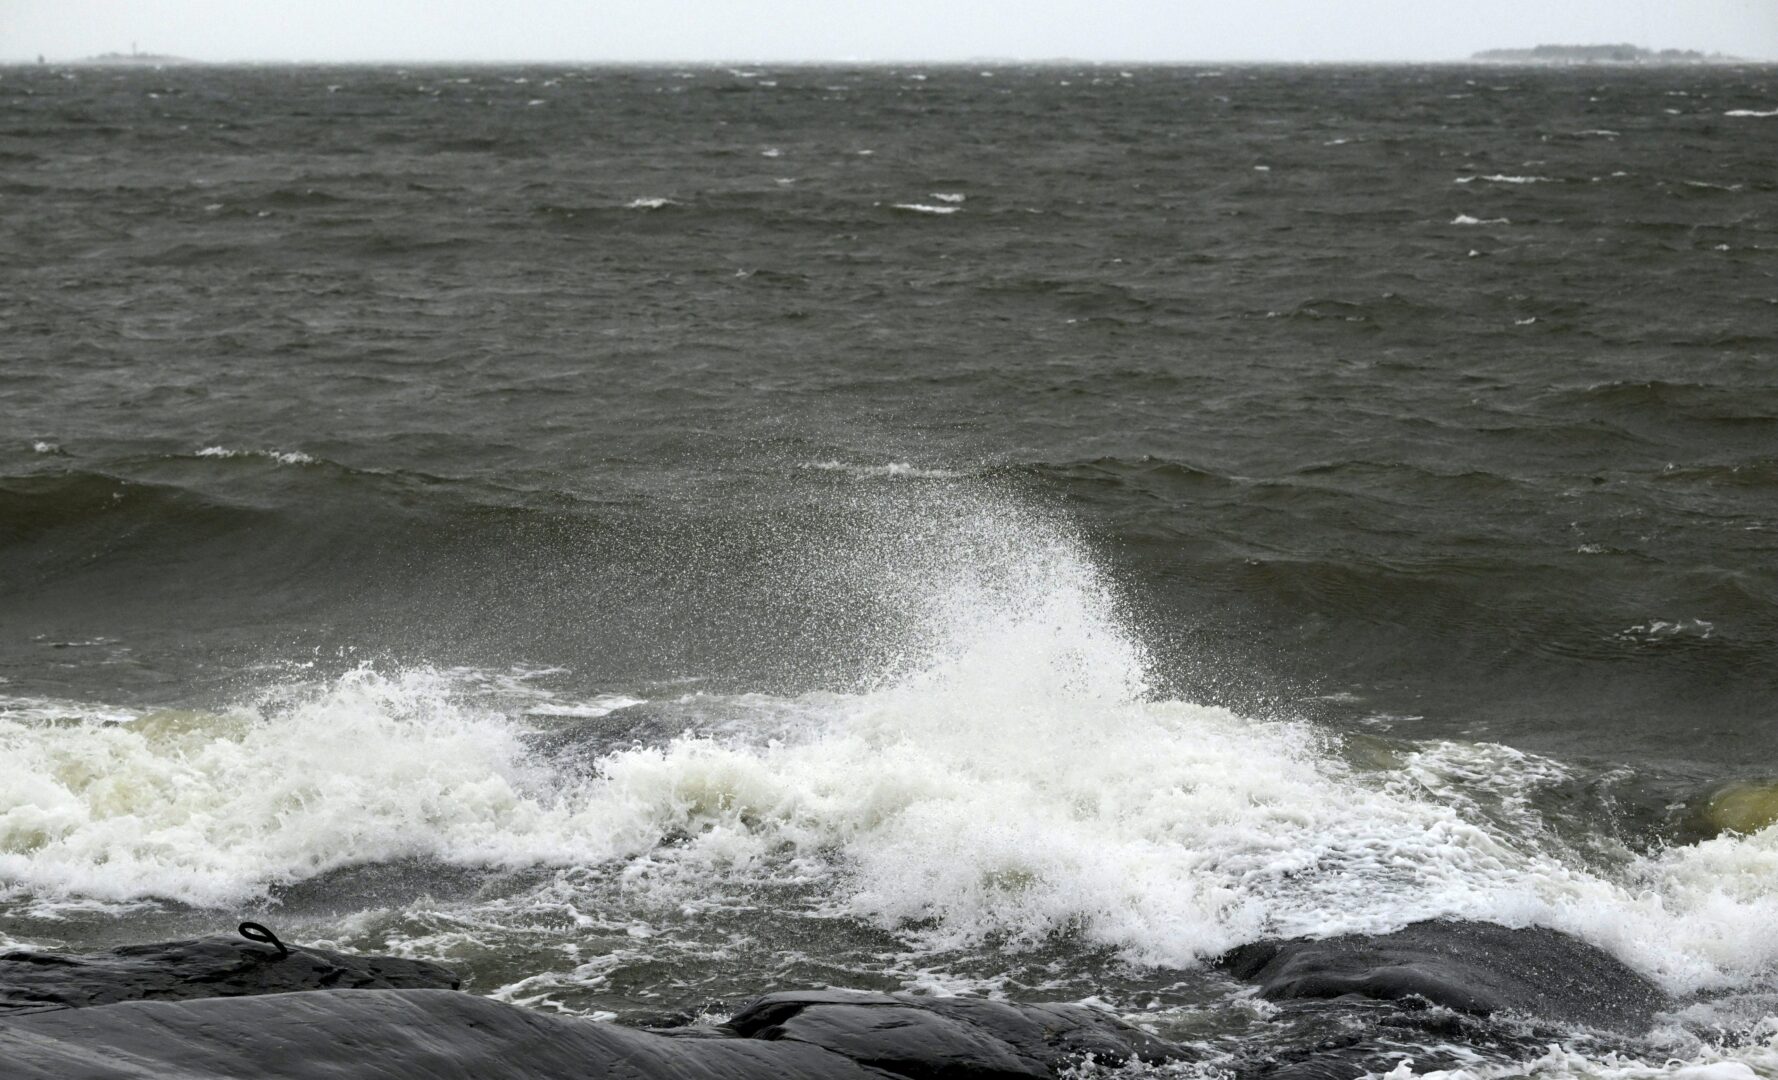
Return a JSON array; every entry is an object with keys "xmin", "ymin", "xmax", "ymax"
[{"xmin": 10, "ymin": 494, "xmax": 1778, "ymax": 993}]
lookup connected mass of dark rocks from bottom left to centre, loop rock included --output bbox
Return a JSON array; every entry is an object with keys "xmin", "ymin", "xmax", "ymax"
[{"xmin": 0, "ymin": 938, "xmax": 1188, "ymax": 1080}]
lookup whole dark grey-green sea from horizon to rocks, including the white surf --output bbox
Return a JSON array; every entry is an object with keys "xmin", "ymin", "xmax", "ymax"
[{"xmin": 0, "ymin": 66, "xmax": 1778, "ymax": 1080}]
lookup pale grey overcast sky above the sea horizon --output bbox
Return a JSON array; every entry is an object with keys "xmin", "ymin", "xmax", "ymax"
[{"xmin": 0, "ymin": 0, "xmax": 1778, "ymax": 60}]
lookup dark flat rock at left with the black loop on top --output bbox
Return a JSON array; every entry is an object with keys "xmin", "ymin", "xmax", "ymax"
[{"xmin": 0, "ymin": 938, "xmax": 459, "ymax": 1016}]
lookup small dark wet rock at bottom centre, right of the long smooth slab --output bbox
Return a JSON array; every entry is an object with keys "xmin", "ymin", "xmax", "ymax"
[{"xmin": 724, "ymin": 991, "xmax": 1184, "ymax": 1080}]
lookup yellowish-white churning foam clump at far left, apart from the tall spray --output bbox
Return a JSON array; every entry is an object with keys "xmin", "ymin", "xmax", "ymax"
[{"xmin": 0, "ymin": 671, "xmax": 597, "ymax": 906}]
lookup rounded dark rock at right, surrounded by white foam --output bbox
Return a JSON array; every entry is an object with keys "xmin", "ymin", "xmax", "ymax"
[{"xmin": 1218, "ymin": 920, "xmax": 1668, "ymax": 1032}]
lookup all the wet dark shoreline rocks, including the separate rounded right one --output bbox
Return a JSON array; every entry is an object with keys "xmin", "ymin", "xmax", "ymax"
[{"xmin": 0, "ymin": 922, "xmax": 1666, "ymax": 1080}]
